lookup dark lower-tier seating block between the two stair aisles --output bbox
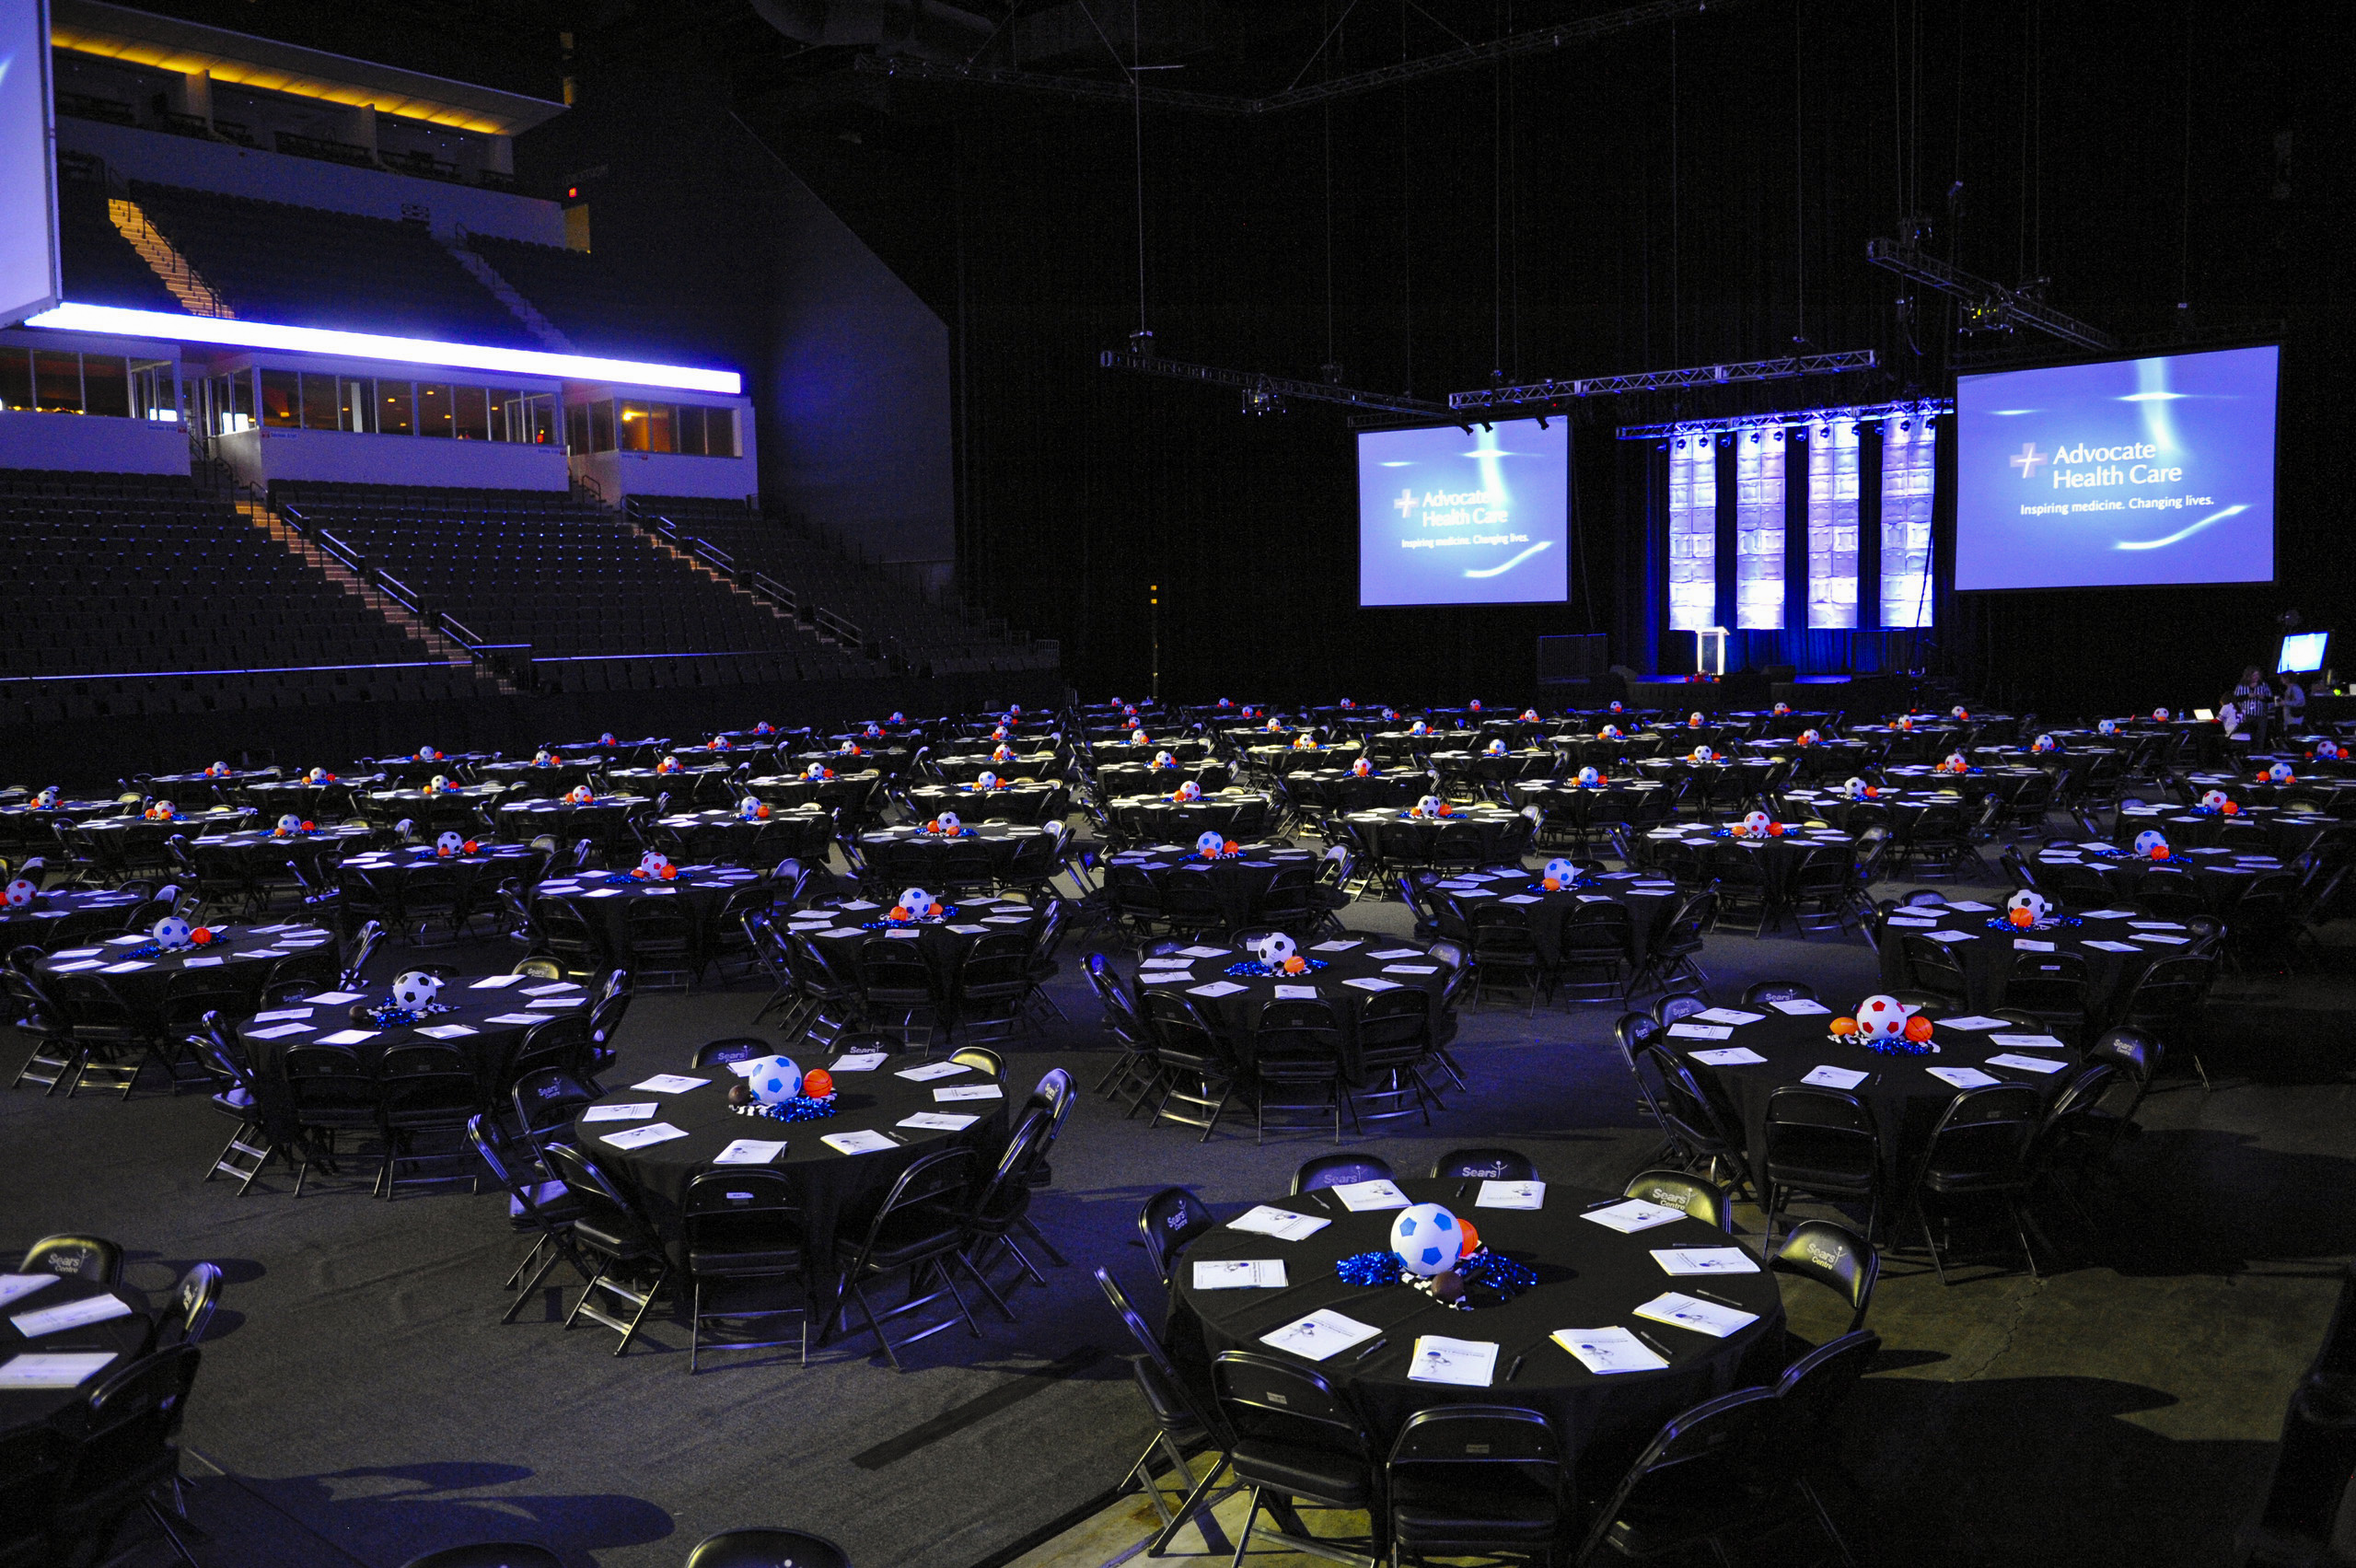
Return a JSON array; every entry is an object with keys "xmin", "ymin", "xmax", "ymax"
[{"xmin": 271, "ymin": 483, "xmax": 876, "ymax": 691}]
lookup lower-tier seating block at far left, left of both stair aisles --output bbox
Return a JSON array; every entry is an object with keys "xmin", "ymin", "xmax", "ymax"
[{"xmin": 0, "ymin": 470, "xmax": 483, "ymax": 722}]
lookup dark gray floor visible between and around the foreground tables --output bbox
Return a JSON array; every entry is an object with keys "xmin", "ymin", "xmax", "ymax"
[{"xmin": 14, "ymin": 858, "xmax": 2356, "ymax": 1568}]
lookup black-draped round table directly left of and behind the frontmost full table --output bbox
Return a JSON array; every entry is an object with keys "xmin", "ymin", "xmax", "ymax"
[{"xmin": 573, "ymin": 1056, "xmax": 1006, "ymax": 1292}]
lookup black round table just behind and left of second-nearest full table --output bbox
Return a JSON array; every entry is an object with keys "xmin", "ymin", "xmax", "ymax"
[{"xmin": 238, "ymin": 974, "xmax": 589, "ymax": 1115}]
